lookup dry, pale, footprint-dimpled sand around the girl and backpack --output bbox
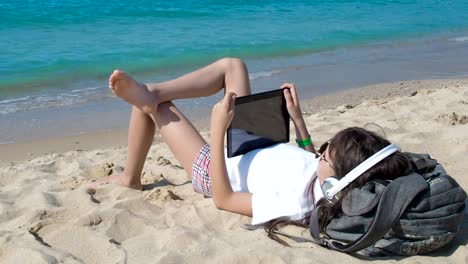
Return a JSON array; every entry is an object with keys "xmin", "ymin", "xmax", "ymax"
[{"xmin": 0, "ymin": 79, "xmax": 468, "ymax": 264}]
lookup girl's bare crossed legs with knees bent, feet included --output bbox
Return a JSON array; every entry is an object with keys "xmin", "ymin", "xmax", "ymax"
[{"xmin": 89, "ymin": 59, "xmax": 254, "ymax": 189}]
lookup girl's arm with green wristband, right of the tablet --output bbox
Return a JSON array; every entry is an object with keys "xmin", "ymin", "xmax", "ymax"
[{"xmin": 281, "ymin": 83, "xmax": 315, "ymax": 153}]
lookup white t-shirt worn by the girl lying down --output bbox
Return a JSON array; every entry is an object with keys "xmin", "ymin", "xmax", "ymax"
[{"xmin": 226, "ymin": 144, "xmax": 321, "ymax": 225}]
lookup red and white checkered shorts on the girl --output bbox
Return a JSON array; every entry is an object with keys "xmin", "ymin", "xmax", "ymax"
[{"xmin": 192, "ymin": 144, "xmax": 212, "ymax": 197}]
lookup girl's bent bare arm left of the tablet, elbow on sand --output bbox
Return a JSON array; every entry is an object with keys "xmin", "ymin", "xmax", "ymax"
[{"xmin": 210, "ymin": 93, "xmax": 252, "ymax": 216}]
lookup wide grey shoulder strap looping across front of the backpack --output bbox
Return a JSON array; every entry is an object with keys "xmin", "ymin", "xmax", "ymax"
[{"xmin": 309, "ymin": 173, "xmax": 427, "ymax": 253}]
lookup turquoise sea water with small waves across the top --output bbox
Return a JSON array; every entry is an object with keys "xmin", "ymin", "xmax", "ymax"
[{"xmin": 0, "ymin": 0, "xmax": 468, "ymax": 141}]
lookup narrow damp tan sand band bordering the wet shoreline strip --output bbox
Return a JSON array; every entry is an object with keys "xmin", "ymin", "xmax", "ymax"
[{"xmin": 0, "ymin": 78, "xmax": 468, "ymax": 166}]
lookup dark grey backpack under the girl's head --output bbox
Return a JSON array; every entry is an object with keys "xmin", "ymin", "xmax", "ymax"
[{"xmin": 310, "ymin": 153, "xmax": 466, "ymax": 256}]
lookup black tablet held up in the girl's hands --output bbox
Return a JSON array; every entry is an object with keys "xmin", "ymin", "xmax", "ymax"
[{"xmin": 227, "ymin": 89, "xmax": 289, "ymax": 158}]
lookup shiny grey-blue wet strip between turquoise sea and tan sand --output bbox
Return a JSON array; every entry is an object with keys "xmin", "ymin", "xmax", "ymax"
[{"xmin": 0, "ymin": 32, "xmax": 468, "ymax": 145}]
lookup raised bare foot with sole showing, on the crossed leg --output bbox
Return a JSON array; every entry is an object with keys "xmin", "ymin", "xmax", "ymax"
[{"xmin": 109, "ymin": 70, "xmax": 158, "ymax": 114}]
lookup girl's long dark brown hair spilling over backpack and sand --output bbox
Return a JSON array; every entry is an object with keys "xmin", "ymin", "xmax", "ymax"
[{"xmin": 265, "ymin": 127, "xmax": 411, "ymax": 245}]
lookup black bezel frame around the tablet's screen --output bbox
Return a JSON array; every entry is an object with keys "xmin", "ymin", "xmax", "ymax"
[{"xmin": 227, "ymin": 88, "xmax": 290, "ymax": 158}]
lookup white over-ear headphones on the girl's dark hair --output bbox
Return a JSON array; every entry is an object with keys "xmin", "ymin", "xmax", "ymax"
[{"xmin": 322, "ymin": 144, "xmax": 398, "ymax": 201}]
